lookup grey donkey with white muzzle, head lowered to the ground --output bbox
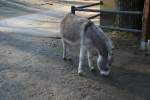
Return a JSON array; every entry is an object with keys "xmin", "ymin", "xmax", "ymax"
[{"xmin": 60, "ymin": 13, "xmax": 114, "ymax": 76}]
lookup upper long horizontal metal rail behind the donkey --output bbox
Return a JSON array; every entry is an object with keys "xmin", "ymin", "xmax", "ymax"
[{"xmin": 75, "ymin": 7, "xmax": 143, "ymax": 15}]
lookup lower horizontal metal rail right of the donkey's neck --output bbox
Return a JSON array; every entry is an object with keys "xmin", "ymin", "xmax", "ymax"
[{"xmin": 99, "ymin": 25, "xmax": 142, "ymax": 33}]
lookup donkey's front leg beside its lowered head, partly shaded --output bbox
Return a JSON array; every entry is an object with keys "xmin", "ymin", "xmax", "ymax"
[{"xmin": 87, "ymin": 47, "xmax": 94, "ymax": 71}]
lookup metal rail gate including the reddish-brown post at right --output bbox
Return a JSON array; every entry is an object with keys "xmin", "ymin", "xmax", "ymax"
[{"xmin": 71, "ymin": 0, "xmax": 150, "ymax": 49}]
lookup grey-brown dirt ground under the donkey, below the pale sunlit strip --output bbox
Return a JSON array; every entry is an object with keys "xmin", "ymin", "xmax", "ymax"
[{"xmin": 0, "ymin": 0, "xmax": 150, "ymax": 100}]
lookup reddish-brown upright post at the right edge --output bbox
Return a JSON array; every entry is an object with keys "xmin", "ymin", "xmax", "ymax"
[{"xmin": 143, "ymin": 0, "xmax": 150, "ymax": 42}]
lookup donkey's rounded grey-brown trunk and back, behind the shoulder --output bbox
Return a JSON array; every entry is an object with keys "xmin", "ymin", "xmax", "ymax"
[{"xmin": 60, "ymin": 14, "xmax": 91, "ymax": 43}]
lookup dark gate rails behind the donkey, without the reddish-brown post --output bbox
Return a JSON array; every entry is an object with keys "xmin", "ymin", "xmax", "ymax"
[{"xmin": 71, "ymin": 2, "xmax": 143, "ymax": 33}]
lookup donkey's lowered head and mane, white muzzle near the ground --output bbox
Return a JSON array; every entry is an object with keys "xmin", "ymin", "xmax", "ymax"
[{"xmin": 97, "ymin": 30, "xmax": 114, "ymax": 76}]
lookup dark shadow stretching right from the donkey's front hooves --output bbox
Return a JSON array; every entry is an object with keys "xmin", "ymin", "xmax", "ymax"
[{"xmin": 83, "ymin": 60, "xmax": 150, "ymax": 100}]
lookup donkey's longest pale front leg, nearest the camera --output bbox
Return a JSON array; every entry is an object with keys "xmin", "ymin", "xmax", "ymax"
[{"xmin": 78, "ymin": 45, "xmax": 86, "ymax": 75}]
